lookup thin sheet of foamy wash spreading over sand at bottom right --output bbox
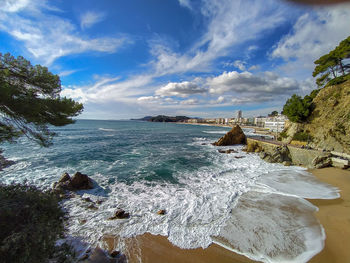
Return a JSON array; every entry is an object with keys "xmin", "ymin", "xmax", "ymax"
[{"xmin": 215, "ymin": 191, "xmax": 325, "ymax": 263}]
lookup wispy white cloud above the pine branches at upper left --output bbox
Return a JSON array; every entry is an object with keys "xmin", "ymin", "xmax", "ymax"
[{"xmin": 0, "ymin": 1, "xmax": 131, "ymax": 65}]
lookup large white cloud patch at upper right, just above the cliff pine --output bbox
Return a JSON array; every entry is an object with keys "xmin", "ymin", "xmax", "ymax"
[{"xmin": 271, "ymin": 4, "xmax": 350, "ymax": 78}]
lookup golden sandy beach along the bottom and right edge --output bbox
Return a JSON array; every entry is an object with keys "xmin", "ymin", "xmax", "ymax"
[{"xmin": 100, "ymin": 168, "xmax": 350, "ymax": 263}]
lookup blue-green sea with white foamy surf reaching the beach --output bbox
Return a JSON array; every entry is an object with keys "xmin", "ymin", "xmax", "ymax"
[{"xmin": 0, "ymin": 120, "xmax": 339, "ymax": 262}]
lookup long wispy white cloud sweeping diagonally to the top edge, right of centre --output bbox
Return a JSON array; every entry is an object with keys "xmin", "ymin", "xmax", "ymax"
[{"xmin": 151, "ymin": 0, "xmax": 287, "ymax": 75}]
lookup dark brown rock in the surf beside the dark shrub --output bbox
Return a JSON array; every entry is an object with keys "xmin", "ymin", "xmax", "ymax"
[{"xmin": 53, "ymin": 172, "xmax": 93, "ymax": 193}]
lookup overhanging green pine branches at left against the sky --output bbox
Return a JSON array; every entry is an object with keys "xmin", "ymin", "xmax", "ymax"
[{"xmin": 0, "ymin": 53, "xmax": 83, "ymax": 146}]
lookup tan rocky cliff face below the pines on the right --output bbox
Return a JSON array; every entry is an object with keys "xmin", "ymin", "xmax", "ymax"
[{"xmin": 286, "ymin": 80, "xmax": 350, "ymax": 154}]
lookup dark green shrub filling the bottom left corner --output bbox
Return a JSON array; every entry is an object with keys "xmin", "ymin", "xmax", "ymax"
[{"xmin": 0, "ymin": 184, "xmax": 69, "ymax": 263}]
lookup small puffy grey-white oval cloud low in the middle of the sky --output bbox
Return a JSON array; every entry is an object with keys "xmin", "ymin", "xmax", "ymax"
[{"xmin": 156, "ymin": 81, "xmax": 207, "ymax": 97}]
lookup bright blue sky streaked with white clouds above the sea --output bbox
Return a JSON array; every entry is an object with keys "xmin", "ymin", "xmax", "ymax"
[{"xmin": 0, "ymin": 0, "xmax": 350, "ymax": 120}]
